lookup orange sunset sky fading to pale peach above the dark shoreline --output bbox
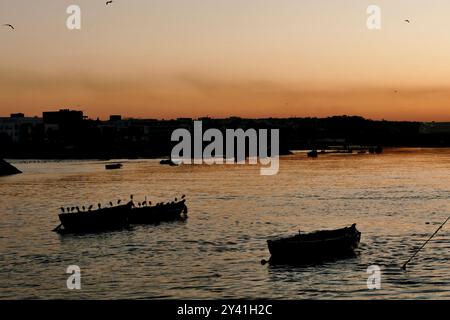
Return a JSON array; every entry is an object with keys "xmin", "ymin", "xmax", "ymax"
[{"xmin": 0, "ymin": 0, "xmax": 450, "ymax": 121}]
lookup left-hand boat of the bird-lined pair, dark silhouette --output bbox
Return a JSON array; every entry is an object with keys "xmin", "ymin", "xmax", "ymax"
[{"xmin": 53, "ymin": 202, "xmax": 132, "ymax": 233}]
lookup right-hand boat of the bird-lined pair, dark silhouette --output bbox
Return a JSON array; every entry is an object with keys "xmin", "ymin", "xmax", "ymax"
[{"xmin": 130, "ymin": 199, "xmax": 187, "ymax": 224}]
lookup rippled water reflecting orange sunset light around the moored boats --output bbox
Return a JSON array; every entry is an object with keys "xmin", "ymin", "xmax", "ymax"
[{"xmin": 0, "ymin": 149, "xmax": 450, "ymax": 299}]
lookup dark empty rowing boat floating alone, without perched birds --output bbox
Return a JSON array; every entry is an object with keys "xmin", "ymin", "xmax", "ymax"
[{"xmin": 267, "ymin": 224, "xmax": 361, "ymax": 263}]
